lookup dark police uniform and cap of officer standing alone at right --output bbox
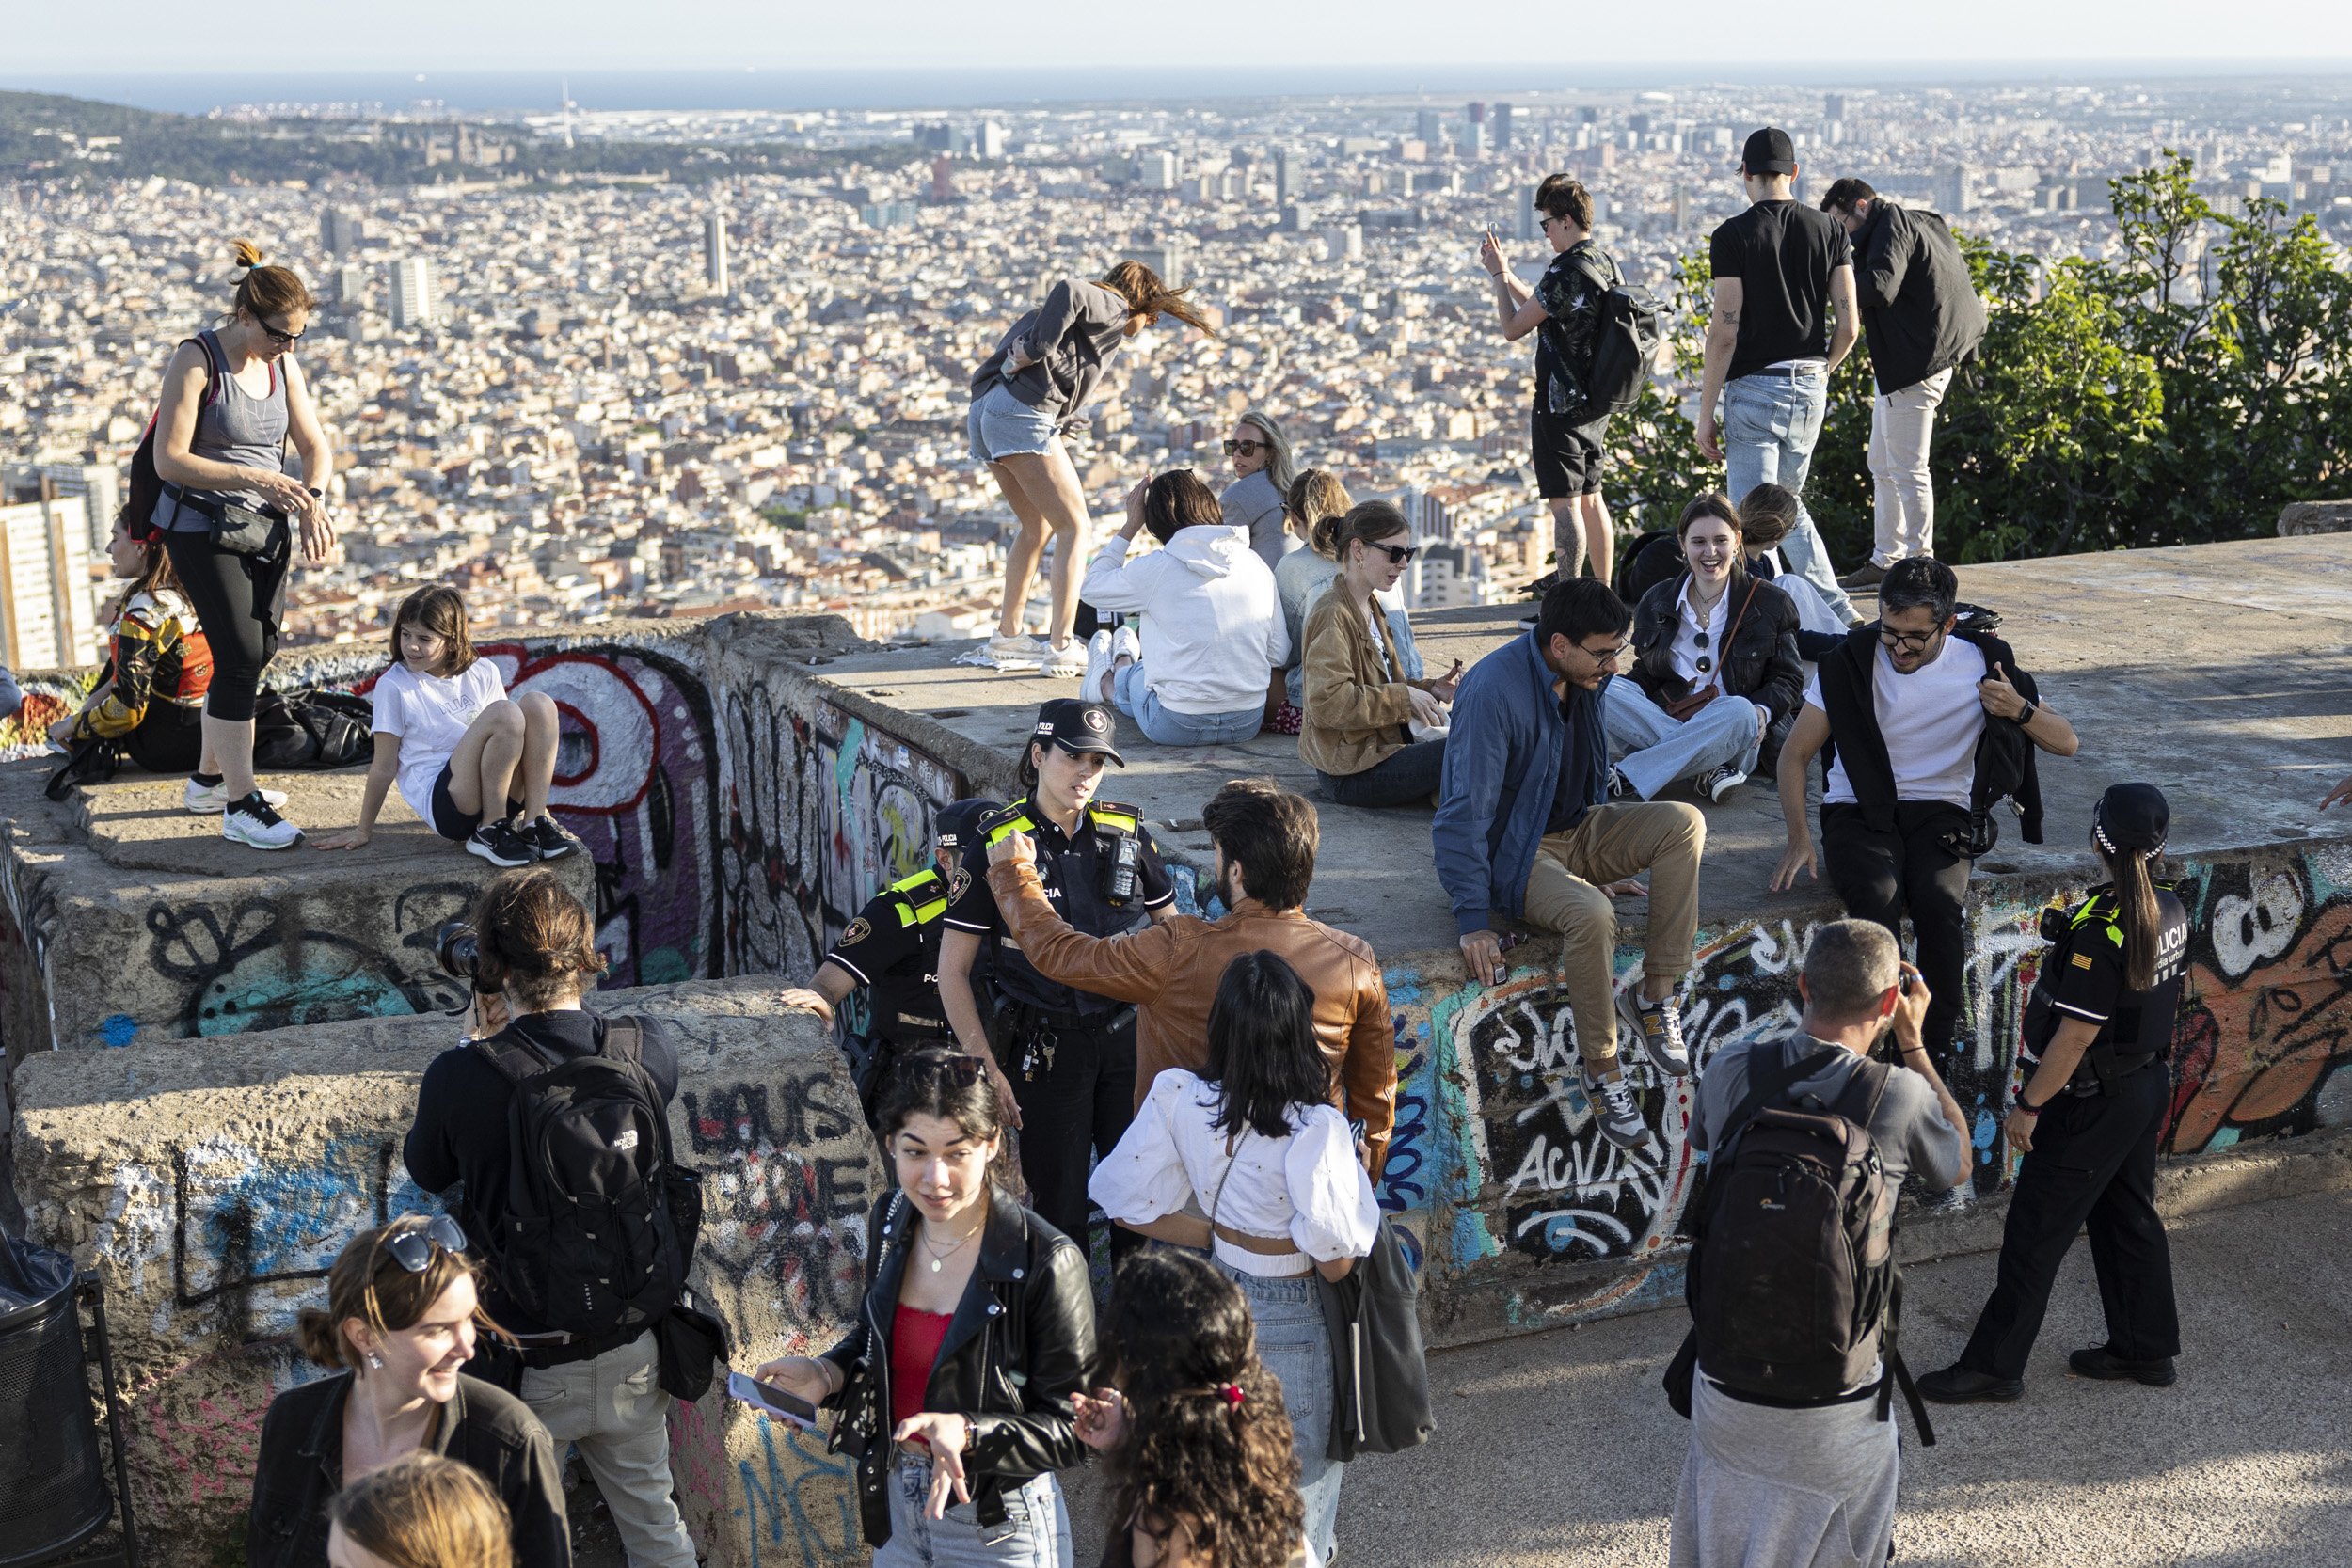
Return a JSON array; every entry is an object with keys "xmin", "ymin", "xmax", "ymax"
[{"xmin": 1960, "ymin": 785, "xmax": 2190, "ymax": 1383}]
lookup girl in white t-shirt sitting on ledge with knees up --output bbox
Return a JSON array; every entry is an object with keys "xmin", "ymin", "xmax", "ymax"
[{"xmin": 315, "ymin": 583, "xmax": 579, "ymax": 865}]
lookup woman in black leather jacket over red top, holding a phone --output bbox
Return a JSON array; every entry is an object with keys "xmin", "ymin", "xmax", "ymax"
[{"xmin": 760, "ymin": 1049, "xmax": 1094, "ymax": 1568}]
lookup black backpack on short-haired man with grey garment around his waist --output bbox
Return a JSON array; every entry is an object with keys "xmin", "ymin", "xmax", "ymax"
[{"xmin": 1684, "ymin": 1046, "xmax": 1936, "ymax": 1444}]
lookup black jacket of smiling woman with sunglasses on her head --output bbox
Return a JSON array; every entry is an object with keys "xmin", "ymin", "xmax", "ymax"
[{"xmin": 245, "ymin": 1373, "xmax": 572, "ymax": 1568}]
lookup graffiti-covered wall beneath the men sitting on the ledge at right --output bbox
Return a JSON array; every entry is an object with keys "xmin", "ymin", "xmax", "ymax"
[{"xmin": 1381, "ymin": 847, "xmax": 2352, "ymax": 1338}]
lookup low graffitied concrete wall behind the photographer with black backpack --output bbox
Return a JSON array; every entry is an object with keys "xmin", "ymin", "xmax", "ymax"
[{"xmin": 17, "ymin": 983, "xmax": 887, "ymax": 1568}]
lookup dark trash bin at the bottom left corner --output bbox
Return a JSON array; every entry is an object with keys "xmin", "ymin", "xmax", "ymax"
[{"xmin": 0, "ymin": 1232, "xmax": 136, "ymax": 1568}]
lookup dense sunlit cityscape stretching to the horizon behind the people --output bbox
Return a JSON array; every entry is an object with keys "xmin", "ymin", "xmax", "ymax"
[{"xmin": 0, "ymin": 82, "xmax": 2352, "ymax": 663}]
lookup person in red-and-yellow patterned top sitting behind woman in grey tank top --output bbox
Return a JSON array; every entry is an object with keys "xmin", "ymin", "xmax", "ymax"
[{"xmin": 50, "ymin": 505, "xmax": 287, "ymax": 816}]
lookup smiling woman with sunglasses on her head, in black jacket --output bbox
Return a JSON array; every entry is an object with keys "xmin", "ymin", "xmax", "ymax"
[{"xmin": 245, "ymin": 1215, "xmax": 572, "ymax": 1568}]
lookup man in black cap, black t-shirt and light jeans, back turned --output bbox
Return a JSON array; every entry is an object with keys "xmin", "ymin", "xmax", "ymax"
[{"xmin": 1698, "ymin": 127, "xmax": 1863, "ymax": 626}]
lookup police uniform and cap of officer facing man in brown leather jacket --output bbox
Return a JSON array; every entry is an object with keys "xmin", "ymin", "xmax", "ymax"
[{"xmin": 946, "ymin": 698, "xmax": 1176, "ymax": 1246}]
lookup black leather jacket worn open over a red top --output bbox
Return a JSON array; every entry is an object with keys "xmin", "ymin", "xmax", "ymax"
[{"xmin": 826, "ymin": 1192, "xmax": 1094, "ymax": 1547}]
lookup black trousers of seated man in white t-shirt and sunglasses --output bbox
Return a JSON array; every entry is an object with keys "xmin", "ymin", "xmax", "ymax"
[{"xmin": 1820, "ymin": 800, "xmax": 1976, "ymax": 1055}]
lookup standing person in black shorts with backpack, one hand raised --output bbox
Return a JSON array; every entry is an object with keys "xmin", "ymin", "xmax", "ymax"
[{"xmin": 1480, "ymin": 174, "xmax": 1618, "ymax": 583}]
